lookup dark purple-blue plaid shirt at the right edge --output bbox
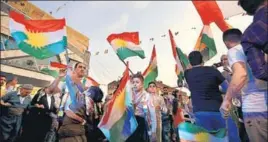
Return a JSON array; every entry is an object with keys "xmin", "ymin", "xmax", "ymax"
[{"xmin": 241, "ymin": 6, "xmax": 268, "ymax": 81}]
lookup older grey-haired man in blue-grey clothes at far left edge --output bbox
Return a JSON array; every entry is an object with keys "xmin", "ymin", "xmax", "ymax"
[{"xmin": 0, "ymin": 84, "xmax": 33, "ymax": 142}]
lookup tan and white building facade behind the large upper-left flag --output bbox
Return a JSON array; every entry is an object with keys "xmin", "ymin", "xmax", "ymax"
[{"xmin": 0, "ymin": 1, "xmax": 90, "ymax": 94}]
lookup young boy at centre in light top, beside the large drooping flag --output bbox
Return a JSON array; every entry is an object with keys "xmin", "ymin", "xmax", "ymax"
[{"xmin": 127, "ymin": 73, "xmax": 156, "ymax": 142}]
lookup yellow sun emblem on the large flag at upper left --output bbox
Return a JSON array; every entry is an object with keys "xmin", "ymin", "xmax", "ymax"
[{"xmin": 26, "ymin": 31, "xmax": 48, "ymax": 48}]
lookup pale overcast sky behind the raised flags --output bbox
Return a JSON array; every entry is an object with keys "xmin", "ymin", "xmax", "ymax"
[{"xmin": 32, "ymin": 1, "xmax": 252, "ymax": 86}]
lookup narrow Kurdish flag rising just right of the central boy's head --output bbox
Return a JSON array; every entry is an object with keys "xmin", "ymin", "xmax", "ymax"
[{"xmin": 143, "ymin": 45, "xmax": 158, "ymax": 88}]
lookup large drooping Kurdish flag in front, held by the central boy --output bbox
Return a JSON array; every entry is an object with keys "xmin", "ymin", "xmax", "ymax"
[{"xmin": 98, "ymin": 64, "xmax": 138, "ymax": 142}]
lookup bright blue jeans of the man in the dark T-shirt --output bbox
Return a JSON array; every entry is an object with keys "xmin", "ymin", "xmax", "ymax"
[{"xmin": 195, "ymin": 111, "xmax": 240, "ymax": 142}]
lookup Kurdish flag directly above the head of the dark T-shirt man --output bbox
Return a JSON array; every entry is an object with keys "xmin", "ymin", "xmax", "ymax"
[{"xmin": 194, "ymin": 25, "xmax": 217, "ymax": 62}]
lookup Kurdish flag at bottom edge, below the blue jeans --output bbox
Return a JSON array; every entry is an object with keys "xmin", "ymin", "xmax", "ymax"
[{"xmin": 178, "ymin": 122, "xmax": 228, "ymax": 142}]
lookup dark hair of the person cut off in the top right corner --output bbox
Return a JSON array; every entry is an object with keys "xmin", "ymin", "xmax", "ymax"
[{"xmin": 238, "ymin": 0, "xmax": 265, "ymax": 15}]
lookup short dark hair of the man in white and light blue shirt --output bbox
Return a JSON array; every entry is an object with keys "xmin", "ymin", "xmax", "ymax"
[{"xmin": 222, "ymin": 29, "xmax": 242, "ymax": 42}]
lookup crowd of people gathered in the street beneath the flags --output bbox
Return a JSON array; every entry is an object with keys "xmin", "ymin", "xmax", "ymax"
[{"xmin": 0, "ymin": 0, "xmax": 268, "ymax": 142}]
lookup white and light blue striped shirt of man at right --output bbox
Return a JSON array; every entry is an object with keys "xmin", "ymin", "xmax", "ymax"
[{"xmin": 228, "ymin": 45, "xmax": 267, "ymax": 118}]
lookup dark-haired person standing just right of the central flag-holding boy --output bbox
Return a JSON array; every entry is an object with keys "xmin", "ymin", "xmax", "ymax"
[{"xmin": 147, "ymin": 82, "xmax": 167, "ymax": 142}]
